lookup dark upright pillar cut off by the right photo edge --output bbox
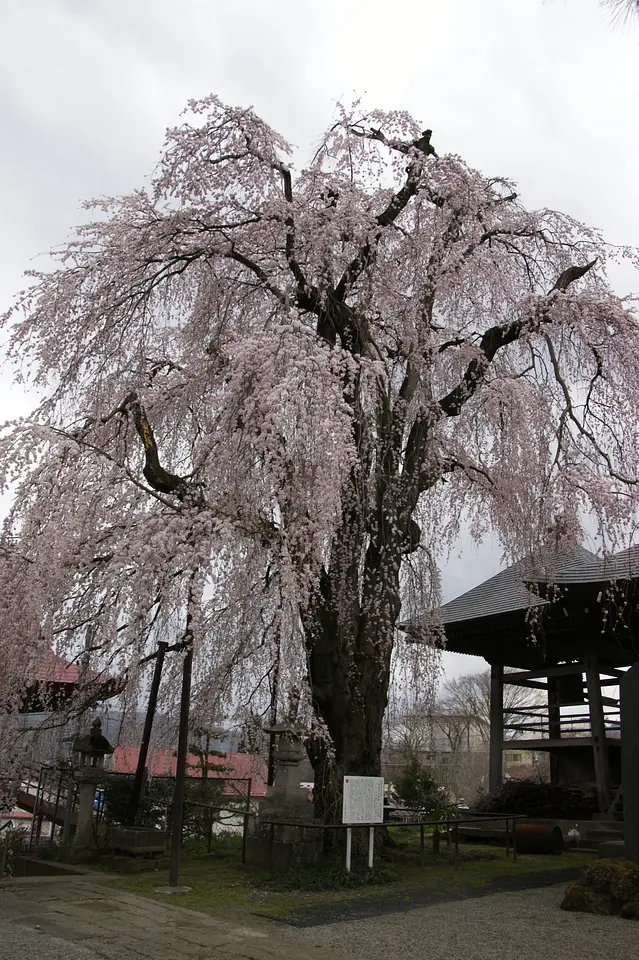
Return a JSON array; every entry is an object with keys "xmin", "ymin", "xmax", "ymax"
[{"xmin": 620, "ymin": 663, "xmax": 639, "ymax": 862}]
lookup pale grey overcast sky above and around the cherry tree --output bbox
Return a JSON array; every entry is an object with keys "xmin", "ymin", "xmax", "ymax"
[{"xmin": 0, "ymin": 0, "xmax": 639, "ymax": 671}]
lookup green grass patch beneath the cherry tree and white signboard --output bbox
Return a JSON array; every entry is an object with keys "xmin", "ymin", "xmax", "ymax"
[{"xmin": 105, "ymin": 828, "xmax": 593, "ymax": 920}]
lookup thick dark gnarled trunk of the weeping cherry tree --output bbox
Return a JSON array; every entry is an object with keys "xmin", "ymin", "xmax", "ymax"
[{"xmin": 304, "ymin": 368, "xmax": 420, "ymax": 822}]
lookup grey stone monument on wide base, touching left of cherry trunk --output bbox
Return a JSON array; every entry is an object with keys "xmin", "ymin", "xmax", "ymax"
[{"xmin": 246, "ymin": 720, "xmax": 322, "ymax": 870}]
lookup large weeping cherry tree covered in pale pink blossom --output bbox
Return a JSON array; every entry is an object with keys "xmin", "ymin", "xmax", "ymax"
[{"xmin": 0, "ymin": 96, "xmax": 639, "ymax": 817}]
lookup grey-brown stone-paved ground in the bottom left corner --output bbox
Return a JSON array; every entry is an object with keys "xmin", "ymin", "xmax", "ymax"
[{"xmin": 0, "ymin": 876, "xmax": 335, "ymax": 960}]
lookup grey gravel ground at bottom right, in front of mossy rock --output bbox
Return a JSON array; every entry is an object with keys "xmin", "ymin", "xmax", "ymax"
[{"xmin": 281, "ymin": 887, "xmax": 639, "ymax": 960}]
